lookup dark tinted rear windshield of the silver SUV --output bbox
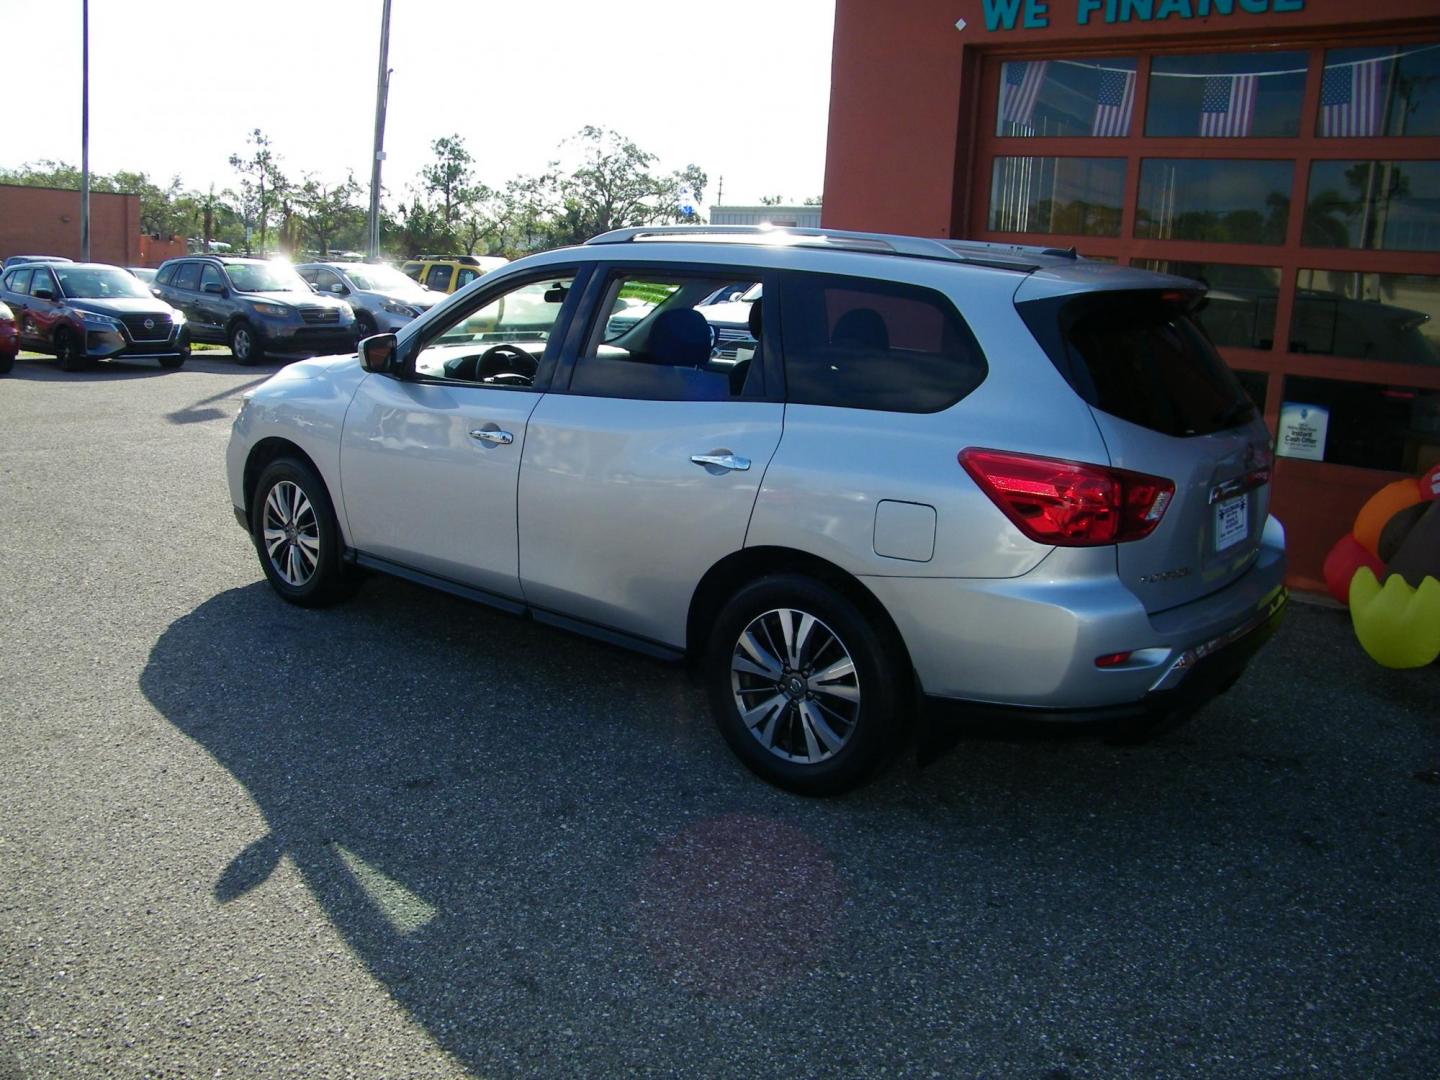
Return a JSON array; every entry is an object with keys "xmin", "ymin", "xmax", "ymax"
[{"xmin": 1020, "ymin": 291, "xmax": 1256, "ymax": 436}]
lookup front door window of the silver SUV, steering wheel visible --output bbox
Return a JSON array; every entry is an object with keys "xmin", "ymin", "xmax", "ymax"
[{"xmin": 415, "ymin": 271, "xmax": 575, "ymax": 389}]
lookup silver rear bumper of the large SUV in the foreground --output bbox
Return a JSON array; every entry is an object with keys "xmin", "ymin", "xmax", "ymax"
[{"xmin": 864, "ymin": 518, "xmax": 1286, "ymax": 719}]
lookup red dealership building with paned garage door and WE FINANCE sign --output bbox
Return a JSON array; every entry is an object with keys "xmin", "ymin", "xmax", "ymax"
[{"xmin": 824, "ymin": 0, "xmax": 1440, "ymax": 589}]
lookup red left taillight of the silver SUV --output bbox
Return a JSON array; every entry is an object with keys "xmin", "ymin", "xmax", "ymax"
[{"xmin": 959, "ymin": 446, "xmax": 1175, "ymax": 547}]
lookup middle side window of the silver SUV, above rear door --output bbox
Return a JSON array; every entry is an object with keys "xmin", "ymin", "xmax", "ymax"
[{"xmin": 570, "ymin": 269, "xmax": 765, "ymax": 402}]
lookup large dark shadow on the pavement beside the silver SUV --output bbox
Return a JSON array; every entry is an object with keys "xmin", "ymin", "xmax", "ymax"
[{"xmin": 141, "ymin": 579, "xmax": 1437, "ymax": 1076}]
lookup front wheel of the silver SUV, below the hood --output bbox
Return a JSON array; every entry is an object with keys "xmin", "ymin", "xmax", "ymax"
[{"xmin": 251, "ymin": 458, "xmax": 353, "ymax": 608}]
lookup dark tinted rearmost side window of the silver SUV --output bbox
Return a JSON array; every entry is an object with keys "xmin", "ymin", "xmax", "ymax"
[{"xmin": 780, "ymin": 274, "xmax": 989, "ymax": 412}]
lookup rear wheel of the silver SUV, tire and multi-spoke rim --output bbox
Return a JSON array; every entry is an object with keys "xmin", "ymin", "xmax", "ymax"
[{"xmin": 704, "ymin": 575, "xmax": 906, "ymax": 795}]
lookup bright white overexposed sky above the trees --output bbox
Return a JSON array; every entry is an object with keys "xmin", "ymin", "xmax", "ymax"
[{"xmin": 0, "ymin": 0, "xmax": 834, "ymax": 206}]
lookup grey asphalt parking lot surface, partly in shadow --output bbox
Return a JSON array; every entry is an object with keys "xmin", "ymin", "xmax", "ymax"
[{"xmin": 0, "ymin": 353, "xmax": 1440, "ymax": 1080}]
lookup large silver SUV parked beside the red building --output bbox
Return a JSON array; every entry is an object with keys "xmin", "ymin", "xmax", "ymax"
[{"xmin": 228, "ymin": 228, "xmax": 1286, "ymax": 793}]
